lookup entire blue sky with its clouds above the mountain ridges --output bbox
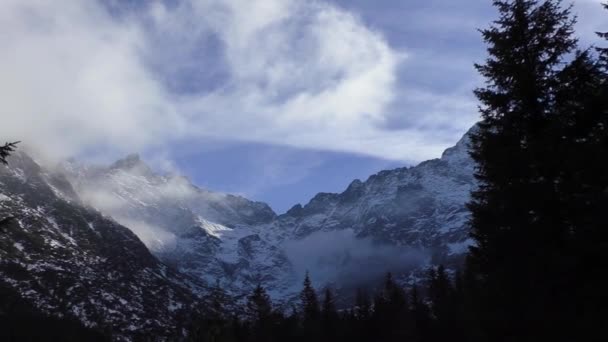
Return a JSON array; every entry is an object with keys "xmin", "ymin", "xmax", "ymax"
[{"xmin": 0, "ymin": 0, "xmax": 608, "ymax": 212}]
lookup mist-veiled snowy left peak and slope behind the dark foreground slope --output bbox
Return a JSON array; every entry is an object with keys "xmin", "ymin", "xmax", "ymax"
[{"xmin": 63, "ymin": 155, "xmax": 291, "ymax": 300}]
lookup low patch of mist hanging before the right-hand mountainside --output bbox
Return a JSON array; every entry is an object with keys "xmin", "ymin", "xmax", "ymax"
[{"xmin": 284, "ymin": 229, "xmax": 429, "ymax": 286}]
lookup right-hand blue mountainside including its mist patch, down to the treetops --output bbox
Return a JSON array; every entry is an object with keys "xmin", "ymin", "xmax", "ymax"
[{"xmin": 262, "ymin": 128, "xmax": 476, "ymax": 292}]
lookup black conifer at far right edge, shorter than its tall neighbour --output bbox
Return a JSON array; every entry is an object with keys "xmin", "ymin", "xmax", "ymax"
[{"xmin": 551, "ymin": 51, "xmax": 608, "ymax": 336}]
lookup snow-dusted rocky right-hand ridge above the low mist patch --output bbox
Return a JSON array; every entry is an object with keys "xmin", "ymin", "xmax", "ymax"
[{"xmin": 273, "ymin": 128, "xmax": 475, "ymax": 254}]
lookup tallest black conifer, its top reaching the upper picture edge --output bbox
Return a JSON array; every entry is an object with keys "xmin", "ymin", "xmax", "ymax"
[{"xmin": 469, "ymin": 0, "xmax": 576, "ymax": 340}]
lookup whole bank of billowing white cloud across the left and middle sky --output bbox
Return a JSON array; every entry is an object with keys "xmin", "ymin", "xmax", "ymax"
[{"xmin": 0, "ymin": 0, "xmax": 456, "ymax": 160}]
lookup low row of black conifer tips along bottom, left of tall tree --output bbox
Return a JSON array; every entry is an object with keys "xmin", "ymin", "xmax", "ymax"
[{"xmin": 189, "ymin": 266, "xmax": 478, "ymax": 342}]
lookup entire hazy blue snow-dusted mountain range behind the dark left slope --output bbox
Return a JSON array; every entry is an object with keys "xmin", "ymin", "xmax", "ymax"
[{"xmin": 63, "ymin": 127, "xmax": 475, "ymax": 299}]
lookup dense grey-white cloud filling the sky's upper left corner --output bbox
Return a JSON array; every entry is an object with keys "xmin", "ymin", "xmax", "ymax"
[{"xmin": 0, "ymin": 0, "xmax": 183, "ymax": 160}]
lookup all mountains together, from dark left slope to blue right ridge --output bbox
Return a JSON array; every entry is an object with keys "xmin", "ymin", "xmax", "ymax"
[{"xmin": 0, "ymin": 127, "xmax": 475, "ymax": 340}]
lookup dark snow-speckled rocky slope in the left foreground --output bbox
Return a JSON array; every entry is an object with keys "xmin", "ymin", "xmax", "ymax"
[{"xmin": 0, "ymin": 153, "xmax": 202, "ymax": 339}]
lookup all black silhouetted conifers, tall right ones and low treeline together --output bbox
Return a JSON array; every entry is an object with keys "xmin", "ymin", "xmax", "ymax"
[{"xmin": 0, "ymin": 0, "xmax": 608, "ymax": 342}]
